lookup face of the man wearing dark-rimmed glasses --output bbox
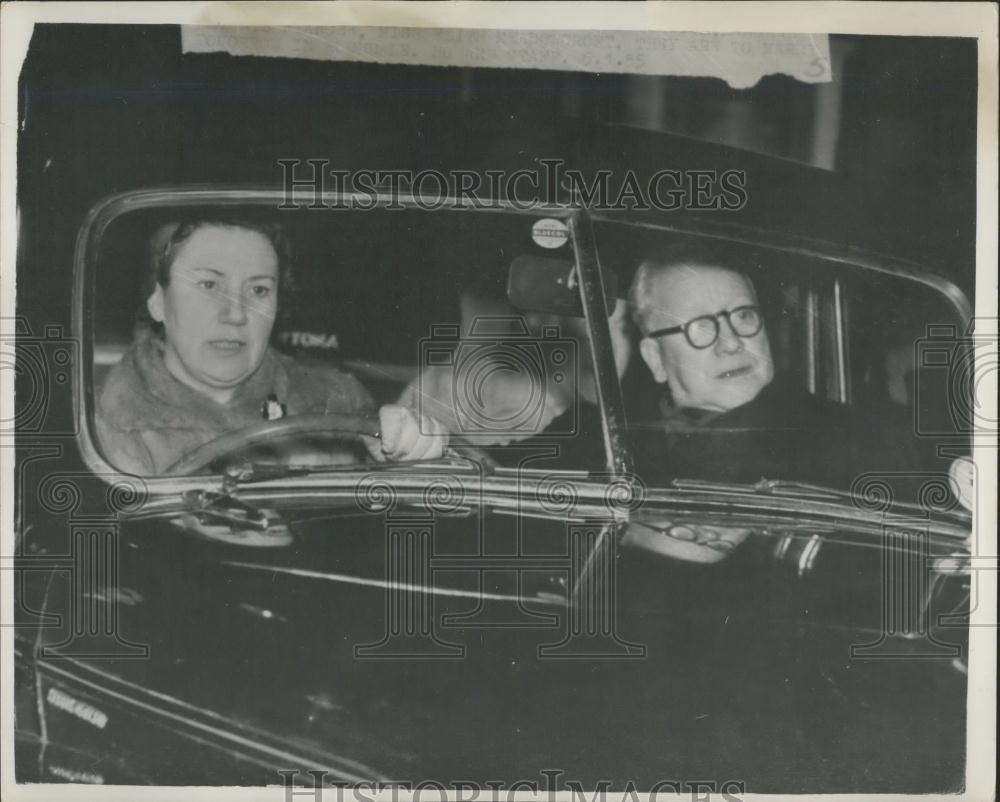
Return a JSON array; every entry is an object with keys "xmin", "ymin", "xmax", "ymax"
[{"xmin": 640, "ymin": 265, "xmax": 774, "ymax": 412}]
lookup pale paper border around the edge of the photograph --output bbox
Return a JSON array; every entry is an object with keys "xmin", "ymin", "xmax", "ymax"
[{"xmin": 0, "ymin": 2, "xmax": 998, "ymax": 802}]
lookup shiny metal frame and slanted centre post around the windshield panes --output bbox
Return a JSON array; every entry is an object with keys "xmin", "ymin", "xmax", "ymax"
[{"xmin": 71, "ymin": 184, "xmax": 972, "ymax": 497}]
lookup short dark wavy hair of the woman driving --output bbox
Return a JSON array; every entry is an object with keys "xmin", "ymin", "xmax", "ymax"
[{"xmin": 136, "ymin": 212, "xmax": 294, "ymax": 336}]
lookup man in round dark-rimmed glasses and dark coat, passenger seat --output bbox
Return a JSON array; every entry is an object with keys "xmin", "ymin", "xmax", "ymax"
[{"xmin": 629, "ymin": 240, "xmax": 914, "ymax": 490}]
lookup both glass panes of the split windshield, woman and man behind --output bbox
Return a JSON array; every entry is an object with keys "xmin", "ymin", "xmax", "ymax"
[{"xmin": 85, "ymin": 198, "xmax": 968, "ymax": 489}]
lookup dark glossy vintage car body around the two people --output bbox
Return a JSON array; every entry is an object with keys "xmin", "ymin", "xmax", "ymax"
[{"xmin": 14, "ymin": 48, "xmax": 971, "ymax": 792}]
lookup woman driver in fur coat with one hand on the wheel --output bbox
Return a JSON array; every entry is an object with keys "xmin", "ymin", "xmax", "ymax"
[{"xmin": 97, "ymin": 216, "xmax": 447, "ymax": 476}]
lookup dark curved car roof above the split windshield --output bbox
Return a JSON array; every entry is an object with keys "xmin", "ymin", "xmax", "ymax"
[{"xmin": 19, "ymin": 69, "xmax": 954, "ymax": 296}]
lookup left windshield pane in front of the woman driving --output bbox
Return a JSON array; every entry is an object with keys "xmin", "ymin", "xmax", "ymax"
[{"xmin": 85, "ymin": 201, "xmax": 612, "ymax": 475}]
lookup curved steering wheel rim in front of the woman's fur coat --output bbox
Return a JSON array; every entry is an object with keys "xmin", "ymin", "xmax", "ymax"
[{"xmin": 166, "ymin": 415, "xmax": 379, "ymax": 475}]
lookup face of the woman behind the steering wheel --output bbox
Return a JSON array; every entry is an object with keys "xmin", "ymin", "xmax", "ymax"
[{"xmin": 146, "ymin": 225, "xmax": 278, "ymax": 403}]
